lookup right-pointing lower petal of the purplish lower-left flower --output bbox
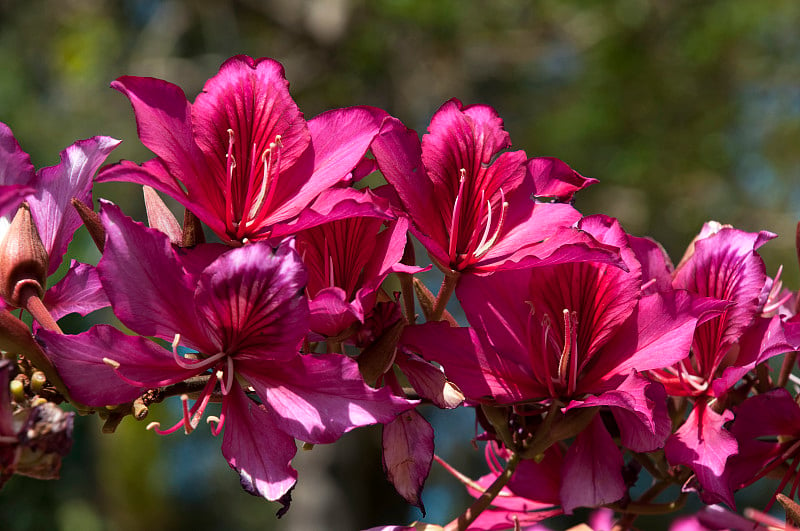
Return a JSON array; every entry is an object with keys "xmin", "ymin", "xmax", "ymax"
[{"xmin": 242, "ymin": 354, "xmax": 416, "ymax": 444}]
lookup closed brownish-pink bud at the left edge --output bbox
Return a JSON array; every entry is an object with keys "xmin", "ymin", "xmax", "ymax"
[{"xmin": 0, "ymin": 203, "xmax": 48, "ymax": 307}]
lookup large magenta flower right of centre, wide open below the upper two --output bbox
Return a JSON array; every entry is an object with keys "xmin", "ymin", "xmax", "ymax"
[{"xmin": 402, "ymin": 216, "xmax": 720, "ymax": 513}]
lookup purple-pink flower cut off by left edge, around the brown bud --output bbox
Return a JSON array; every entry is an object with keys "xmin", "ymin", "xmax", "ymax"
[{"xmin": 0, "ymin": 123, "xmax": 120, "ymax": 320}]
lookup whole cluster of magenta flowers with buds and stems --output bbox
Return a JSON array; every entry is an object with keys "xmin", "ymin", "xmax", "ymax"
[{"xmin": 0, "ymin": 56, "xmax": 800, "ymax": 529}]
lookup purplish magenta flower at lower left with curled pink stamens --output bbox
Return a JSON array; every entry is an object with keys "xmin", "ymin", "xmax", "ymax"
[{"xmin": 38, "ymin": 205, "xmax": 415, "ymax": 500}]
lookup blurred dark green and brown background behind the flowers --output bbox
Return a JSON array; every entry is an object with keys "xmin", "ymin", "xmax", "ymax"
[{"xmin": 0, "ymin": 0, "xmax": 800, "ymax": 531}]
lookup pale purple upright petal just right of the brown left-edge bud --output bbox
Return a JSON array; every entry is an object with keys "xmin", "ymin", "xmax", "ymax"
[{"xmin": 28, "ymin": 136, "xmax": 120, "ymax": 274}]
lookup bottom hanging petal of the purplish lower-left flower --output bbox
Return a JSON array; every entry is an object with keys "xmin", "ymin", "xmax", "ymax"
[{"xmin": 222, "ymin": 383, "xmax": 297, "ymax": 500}]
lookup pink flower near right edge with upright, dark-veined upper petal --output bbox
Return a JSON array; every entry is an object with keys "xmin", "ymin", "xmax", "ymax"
[{"xmin": 649, "ymin": 223, "xmax": 797, "ymax": 507}]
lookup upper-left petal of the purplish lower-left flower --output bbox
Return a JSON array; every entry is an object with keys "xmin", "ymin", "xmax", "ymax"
[{"xmin": 97, "ymin": 203, "xmax": 216, "ymax": 354}]
